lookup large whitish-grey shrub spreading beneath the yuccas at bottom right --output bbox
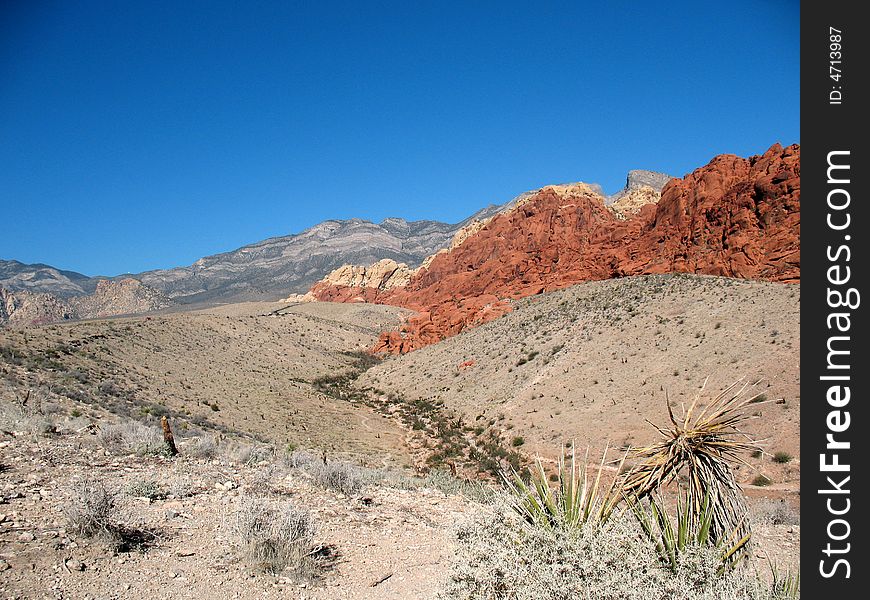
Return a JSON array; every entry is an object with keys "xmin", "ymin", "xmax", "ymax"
[{"xmin": 440, "ymin": 506, "xmax": 795, "ymax": 600}]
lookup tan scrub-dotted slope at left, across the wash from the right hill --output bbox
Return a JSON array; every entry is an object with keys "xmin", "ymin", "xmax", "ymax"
[{"xmin": 0, "ymin": 303, "xmax": 416, "ymax": 463}]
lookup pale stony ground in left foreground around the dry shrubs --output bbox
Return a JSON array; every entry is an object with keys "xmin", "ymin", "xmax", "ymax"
[{"xmin": 0, "ymin": 420, "xmax": 475, "ymax": 600}]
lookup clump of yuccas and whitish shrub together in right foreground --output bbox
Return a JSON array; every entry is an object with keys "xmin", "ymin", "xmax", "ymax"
[{"xmin": 444, "ymin": 386, "xmax": 800, "ymax": 600}]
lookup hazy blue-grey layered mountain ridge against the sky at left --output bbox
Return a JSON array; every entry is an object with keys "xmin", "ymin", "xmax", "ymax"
[{"xmin": 0, "ymin": 205, "xmax": 500, "ymax": 303}]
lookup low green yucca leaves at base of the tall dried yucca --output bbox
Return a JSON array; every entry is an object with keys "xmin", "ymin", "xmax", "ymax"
[{"xmin": 628, "ymin": 493, "xmax": 750, "ymax": 575}]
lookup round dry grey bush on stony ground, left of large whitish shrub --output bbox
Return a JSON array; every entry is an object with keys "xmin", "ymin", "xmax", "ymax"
[{"xmin": 234, "ymin": 498, "xmax": 317, "ymax": 578}]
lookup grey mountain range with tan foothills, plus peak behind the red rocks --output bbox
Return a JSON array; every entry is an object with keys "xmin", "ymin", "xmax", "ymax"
[{"xmin": 0, "ymin": 171, "xmax": 669, "ymax": 325}]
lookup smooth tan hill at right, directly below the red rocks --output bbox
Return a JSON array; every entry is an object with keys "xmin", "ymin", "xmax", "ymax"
[{"xmin": 357, "ymin": 275, "xmax": 800, "ymax": 493}]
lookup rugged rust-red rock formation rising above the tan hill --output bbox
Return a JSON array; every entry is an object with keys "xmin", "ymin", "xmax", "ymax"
[{"xmin": 312, "ymin": 144, "xmax": 800, "ymax": 353}]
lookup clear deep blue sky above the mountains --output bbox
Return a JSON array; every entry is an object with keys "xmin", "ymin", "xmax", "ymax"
[{"xmin": 0, "ymin": 0, "xmax": 800, "ymax": 275}]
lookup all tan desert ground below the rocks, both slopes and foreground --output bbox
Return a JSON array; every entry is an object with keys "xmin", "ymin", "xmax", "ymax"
[{"xmin": 0, "ymin": 275, "xmax": 800, "ymax": 600}]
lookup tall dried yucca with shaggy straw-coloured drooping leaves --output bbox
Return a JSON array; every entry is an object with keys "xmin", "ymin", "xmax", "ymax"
[{"xmin": 622, "ymin": 380, "xmax": 758, "ymax": 542}]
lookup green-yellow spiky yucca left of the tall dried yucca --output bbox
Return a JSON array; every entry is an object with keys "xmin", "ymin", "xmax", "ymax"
[{"xmin": 503, "ymin": 443, "xmax": 625, "ymax": 530}]
